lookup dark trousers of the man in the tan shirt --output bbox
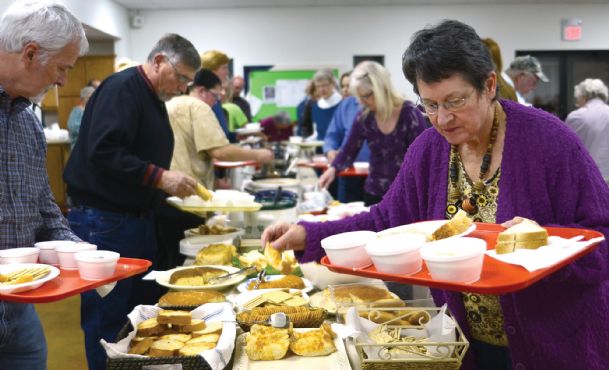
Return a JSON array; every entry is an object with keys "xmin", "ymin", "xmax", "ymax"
[{"xmin": 155, "ymin": 204, "xmax": 205, "ymax": 270}]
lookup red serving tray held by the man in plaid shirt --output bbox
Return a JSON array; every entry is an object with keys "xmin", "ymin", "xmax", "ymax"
[{"xmin": 0, "ymin": 257, "xmax": 152, "ymax": 303}]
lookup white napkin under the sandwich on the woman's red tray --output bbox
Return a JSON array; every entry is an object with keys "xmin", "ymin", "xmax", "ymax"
[{"xmin": 486, "ymin": 236, "xmax": 605, "ymax": 272}]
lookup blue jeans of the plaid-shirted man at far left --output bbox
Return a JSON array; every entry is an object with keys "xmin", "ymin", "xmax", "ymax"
[{"xmin": 0, "ymin": 300, "xmax": 47, "ymax": 370}]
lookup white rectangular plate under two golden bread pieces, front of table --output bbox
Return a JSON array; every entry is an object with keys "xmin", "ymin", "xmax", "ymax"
[{"xmin": 233, "ymin": 328, "xmax": 351, "ymax": 370}]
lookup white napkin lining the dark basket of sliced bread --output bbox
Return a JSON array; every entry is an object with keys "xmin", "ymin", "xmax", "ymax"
[{"xmin": 99, "ymin": 302, "xmax": 237, "ymax": 370}]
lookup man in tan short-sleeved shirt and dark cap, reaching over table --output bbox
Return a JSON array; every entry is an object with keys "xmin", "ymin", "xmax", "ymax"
[{"xmin": 157, "ymin": 69, "xmax": 273, "ymax": 269}]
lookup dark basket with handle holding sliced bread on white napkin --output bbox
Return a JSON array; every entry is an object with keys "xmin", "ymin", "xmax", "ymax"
[{"xmin": 106, "ymin": 322, "xmax": 212, "ymax": 370}]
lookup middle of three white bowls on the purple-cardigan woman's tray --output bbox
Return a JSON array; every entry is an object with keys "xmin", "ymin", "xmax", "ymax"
[{"xmin": 366, "ymin": 233, "xmax": 425, "ymax": 275}]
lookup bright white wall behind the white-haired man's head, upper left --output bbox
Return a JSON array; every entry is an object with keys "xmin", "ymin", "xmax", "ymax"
[{"xmin": 0, "ymin": 0, "xmax": 131, "ymax": 55}]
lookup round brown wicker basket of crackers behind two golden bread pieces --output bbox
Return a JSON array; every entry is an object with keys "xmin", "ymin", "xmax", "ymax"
[{"xmin": 237, "ymin": 306, "xmax": 328, "ymax": 331}]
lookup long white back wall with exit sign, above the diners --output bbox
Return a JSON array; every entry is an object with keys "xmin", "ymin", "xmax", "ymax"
[{"xmin": 128, "ymin": 4, "xmax": 609, "ymax": 98}]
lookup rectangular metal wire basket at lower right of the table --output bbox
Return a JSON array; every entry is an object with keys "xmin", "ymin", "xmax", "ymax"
[{"xmin": 346, "ymin": 307, "xmax": 469, "ymax": 370}]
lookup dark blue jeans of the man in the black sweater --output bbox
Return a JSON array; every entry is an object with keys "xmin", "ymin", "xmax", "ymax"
[{"xmin": 68, "ymin": 207, "xmax": 160, "ymax": 370}]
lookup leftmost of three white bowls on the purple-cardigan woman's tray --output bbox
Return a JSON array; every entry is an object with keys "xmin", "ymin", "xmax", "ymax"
[{"xmin": 321, "ymin": 231, "xmax": 376, "ymax": 268}]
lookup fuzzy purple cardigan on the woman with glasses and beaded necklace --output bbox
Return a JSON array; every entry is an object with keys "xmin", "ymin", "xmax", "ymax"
[{"xmin": 298, "ymin": 101, "xmax": 609, "ymax": 370}]
